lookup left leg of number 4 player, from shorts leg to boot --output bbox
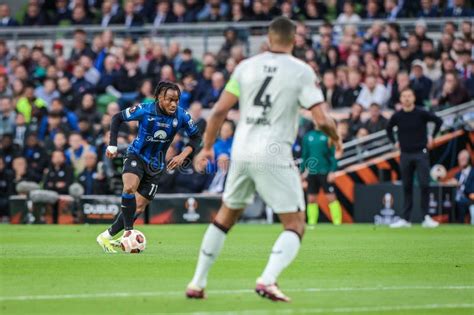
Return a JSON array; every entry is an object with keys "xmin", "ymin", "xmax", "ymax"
[{"xmin": 186, "ymin": 165, "xmax": 255, "ymax": 299}]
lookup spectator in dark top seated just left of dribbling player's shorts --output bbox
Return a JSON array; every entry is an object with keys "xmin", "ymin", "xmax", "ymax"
[{"xmin": 77, "ymin": 151, "xmax": 108, "ymax": 195}]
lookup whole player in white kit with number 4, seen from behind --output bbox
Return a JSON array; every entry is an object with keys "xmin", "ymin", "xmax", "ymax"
[{"xmin": 186, "ymin": 17, "xmax": 339, "ymax": 302}]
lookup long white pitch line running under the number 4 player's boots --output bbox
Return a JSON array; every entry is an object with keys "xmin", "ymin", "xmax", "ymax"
[{"xmin": 0, "ymin": 285, "xmax": 474, "ymax": 302}]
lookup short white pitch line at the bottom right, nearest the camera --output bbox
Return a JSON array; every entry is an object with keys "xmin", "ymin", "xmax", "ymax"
[{"xmin": 178, "ymin": 304, "xmax": 474, "ymax": 315}]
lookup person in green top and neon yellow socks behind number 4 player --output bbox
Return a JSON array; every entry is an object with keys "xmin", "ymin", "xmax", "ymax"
[{"xmin": 300, "ymin": 127, "xmax": 342, "ymax": 225}]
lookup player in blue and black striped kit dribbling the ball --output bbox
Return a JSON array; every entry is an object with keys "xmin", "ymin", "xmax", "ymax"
[{"xmin": 97, "ymin": 82, "xmax": 201, "ymax": 253}]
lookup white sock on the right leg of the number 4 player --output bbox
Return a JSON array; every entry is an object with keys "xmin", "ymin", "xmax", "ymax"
[{"xmin": 260, "ymin": 231, "xmax": 301, "ymax": 285}]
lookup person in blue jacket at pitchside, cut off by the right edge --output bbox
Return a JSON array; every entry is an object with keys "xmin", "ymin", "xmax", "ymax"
[{"xmin": 453, "ymin": 150, "xmax": 474, "ymax": 224}]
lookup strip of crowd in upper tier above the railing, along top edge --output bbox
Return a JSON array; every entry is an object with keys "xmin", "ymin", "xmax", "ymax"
[{"xmin": 0, "ymin": 0, "xmax": 473, "ymax": 27}]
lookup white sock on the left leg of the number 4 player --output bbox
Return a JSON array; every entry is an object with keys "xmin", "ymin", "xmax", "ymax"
[{"xmin": 191, "ymin": 224, "xmax": 226, "ymax": 289}]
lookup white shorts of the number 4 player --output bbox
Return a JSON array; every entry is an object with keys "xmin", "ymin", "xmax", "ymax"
[{"xmin": 223, "ymin": 161, "xmax": 305, "ymax": 213}]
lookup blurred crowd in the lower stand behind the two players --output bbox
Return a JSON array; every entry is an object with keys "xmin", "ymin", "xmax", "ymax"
[{"xmin": 0, "ymin": 6, "xmax": 474, "ymax": 218}]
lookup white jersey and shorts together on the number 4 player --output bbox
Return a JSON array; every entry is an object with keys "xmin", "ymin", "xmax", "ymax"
[{"xmin": 223, "ymin": 52, "xmax": 324, "ymax": 213}]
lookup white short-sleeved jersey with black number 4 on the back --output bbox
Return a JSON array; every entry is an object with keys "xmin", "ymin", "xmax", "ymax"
[{"xmin": 226, "ymin": 52, "xmax": 324, "ymax": 162}]
